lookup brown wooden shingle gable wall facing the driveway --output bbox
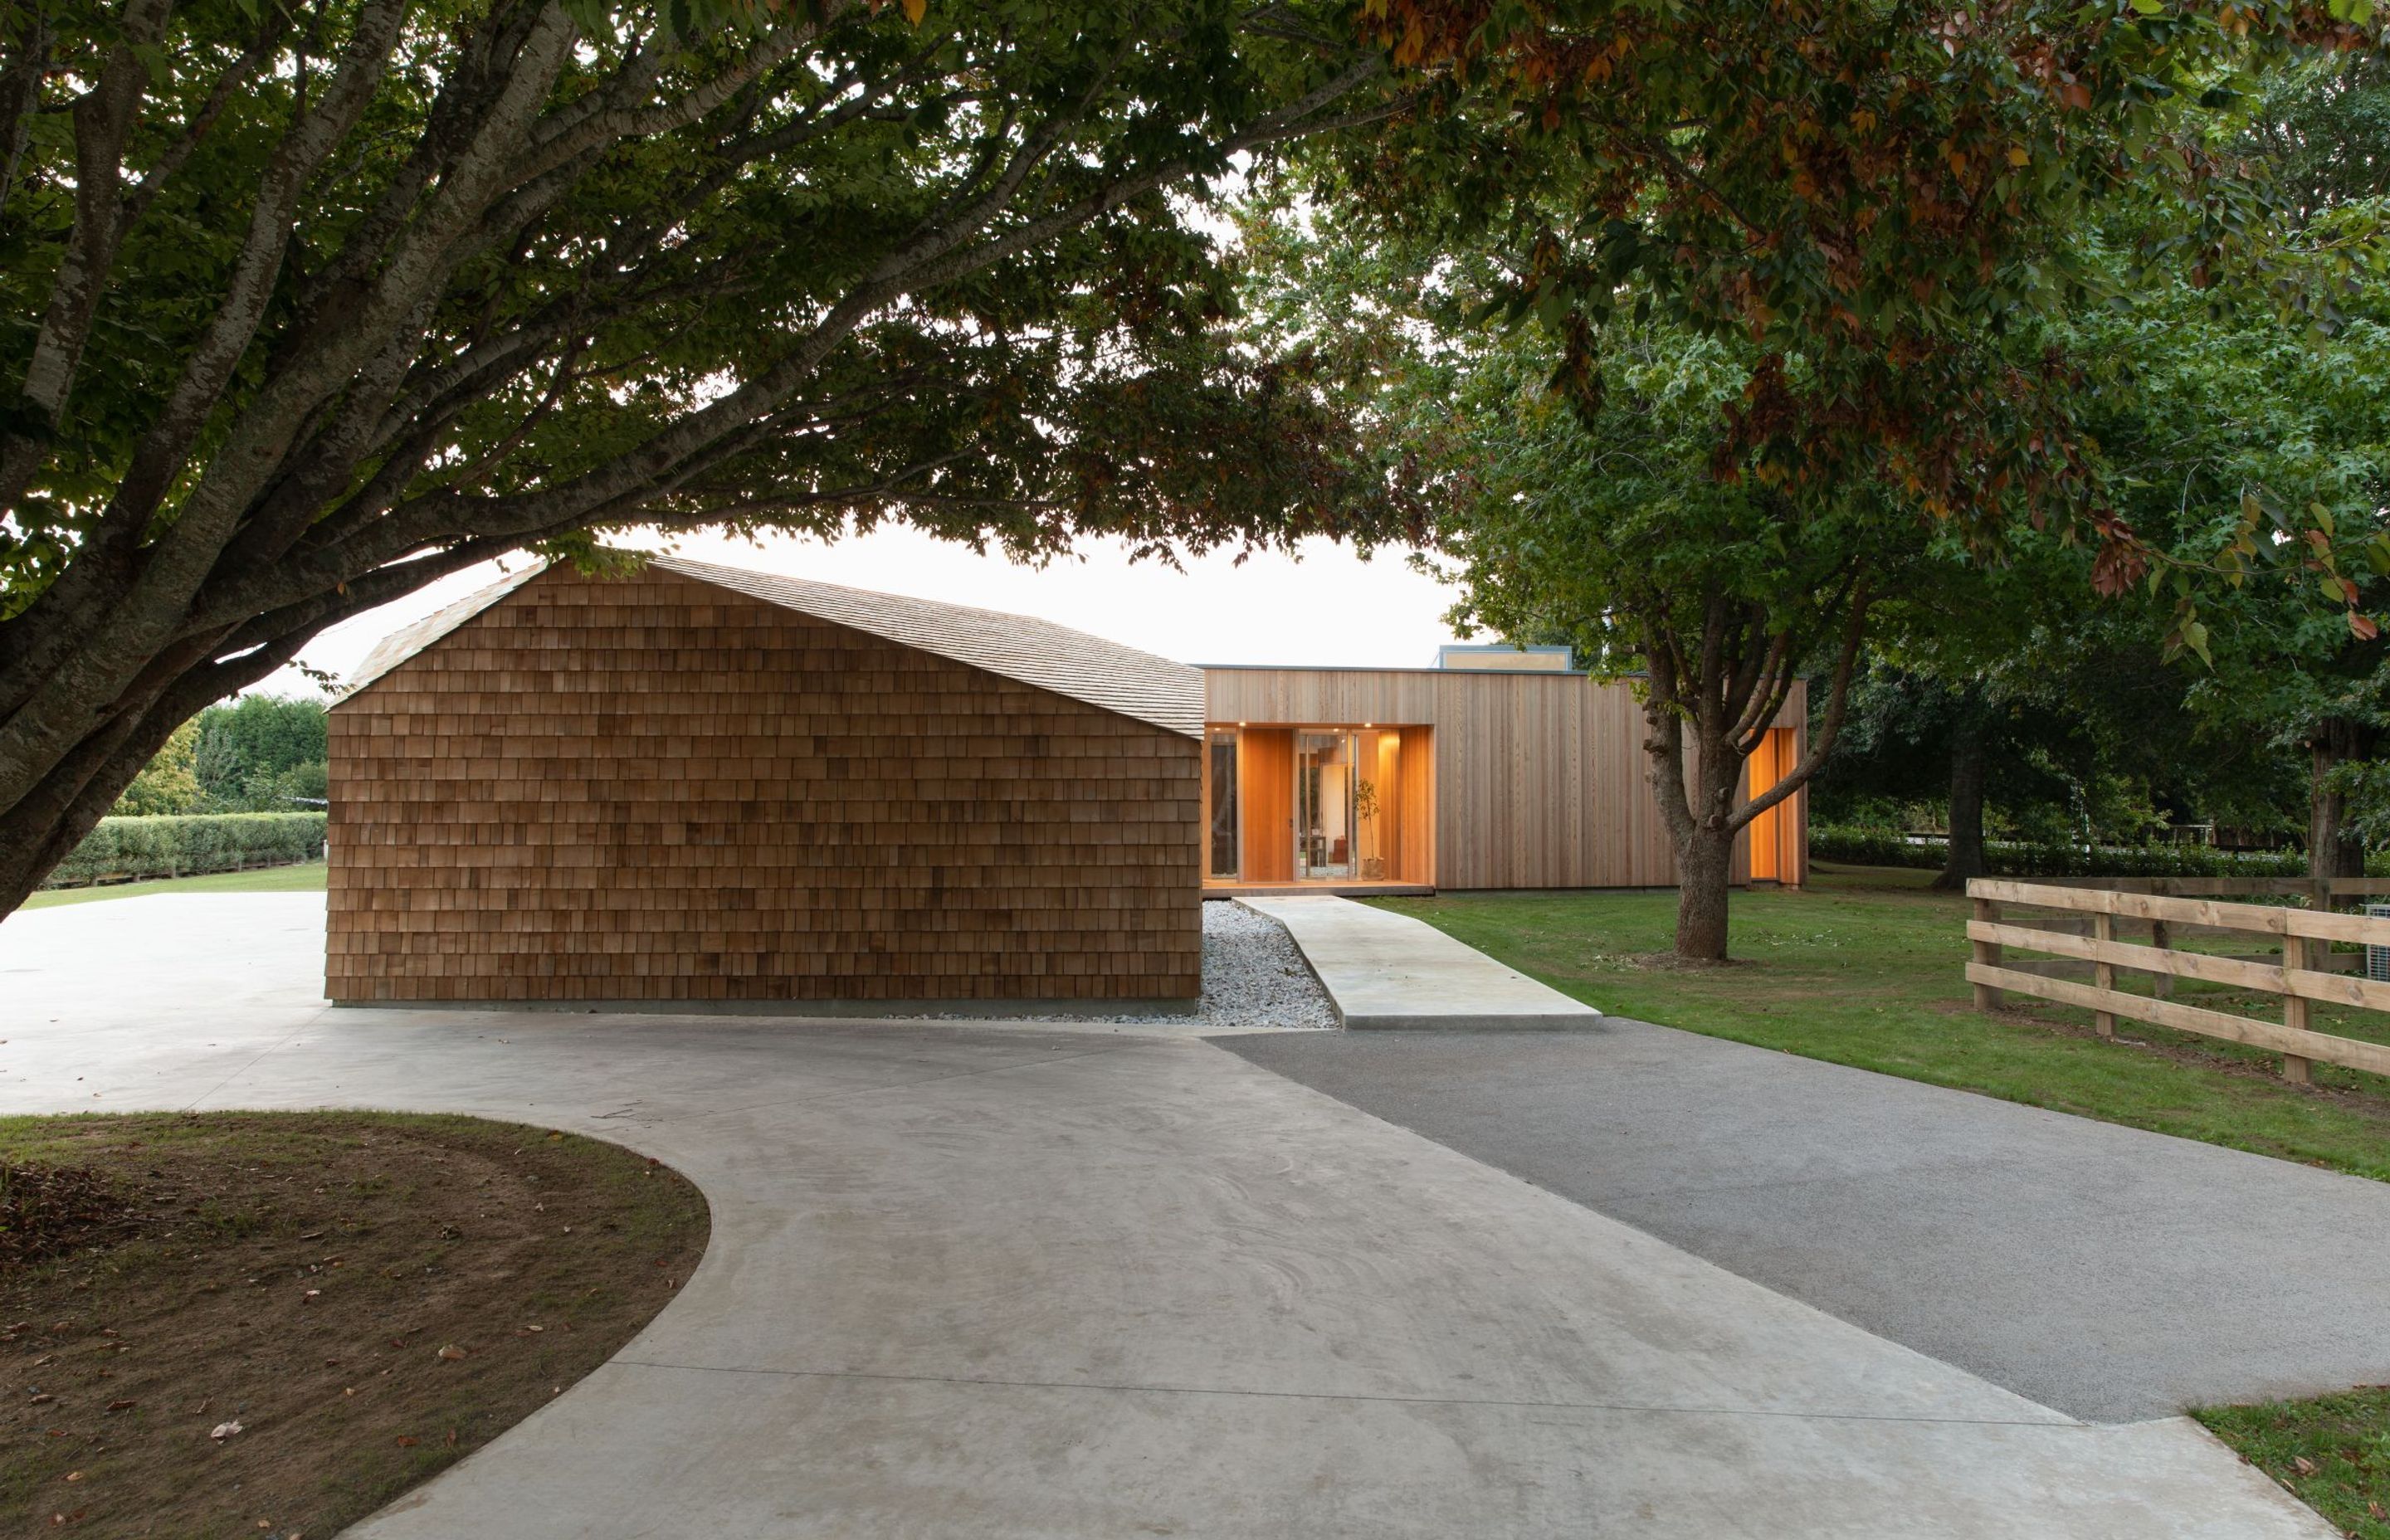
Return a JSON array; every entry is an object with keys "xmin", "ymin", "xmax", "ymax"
[{"xmin": 325, "ymin": 569, "xmax": 1202, "ymax": 1002}]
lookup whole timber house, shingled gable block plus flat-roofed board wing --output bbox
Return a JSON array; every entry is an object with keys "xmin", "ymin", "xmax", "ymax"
[{"xmin": 325, "ymin": 558, "xmax": 1807, "ymax": 1011}]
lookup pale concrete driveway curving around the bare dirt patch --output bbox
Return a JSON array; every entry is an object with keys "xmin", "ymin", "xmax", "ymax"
[{"xmin": 0, "ymin": 894, "xmax": 2330, "ymax": 1540}]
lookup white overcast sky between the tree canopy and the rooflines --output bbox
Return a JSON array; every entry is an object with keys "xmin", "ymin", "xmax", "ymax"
[{"xmin": 258, "ymin": 529, "xmax": 1489, "ymax": 694}]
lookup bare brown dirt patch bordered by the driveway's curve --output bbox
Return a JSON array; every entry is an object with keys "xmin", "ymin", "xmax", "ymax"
[{"xmin": 0, "ymin": 1112, "xmax": 707, "ymax": 1540}]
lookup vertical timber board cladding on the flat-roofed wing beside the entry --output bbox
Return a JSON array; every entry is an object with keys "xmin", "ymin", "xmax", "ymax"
[{"xmin": 1205, "ymin": 667, "xmax": 1809, "ymax": 889}]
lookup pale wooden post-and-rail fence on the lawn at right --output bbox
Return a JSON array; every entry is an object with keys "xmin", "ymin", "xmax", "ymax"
[{"xmin": 1967, "ymin": 878, "xmax": 2390, "ymax": 1084}]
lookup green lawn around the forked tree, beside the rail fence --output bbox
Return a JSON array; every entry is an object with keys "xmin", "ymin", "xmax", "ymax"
[{"xmin": 1379, "ymin": 868, "xmax": 2390, "ymax": 1179}]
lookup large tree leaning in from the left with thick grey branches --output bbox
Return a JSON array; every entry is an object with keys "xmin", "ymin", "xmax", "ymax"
[{"xmin": 0, "ymin": 0, "xmax": 1403, "ymax": 914}]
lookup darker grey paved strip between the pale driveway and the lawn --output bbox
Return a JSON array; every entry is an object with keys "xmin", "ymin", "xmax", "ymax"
[{"xmin": 1226, "ymin": 1016, "xmax": 2390, "ymax": 1421}]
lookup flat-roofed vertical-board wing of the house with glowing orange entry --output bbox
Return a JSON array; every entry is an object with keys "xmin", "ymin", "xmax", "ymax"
[{"xmin": 1205, "ymin": 646, "xmax": 1809, "ymax": 894}]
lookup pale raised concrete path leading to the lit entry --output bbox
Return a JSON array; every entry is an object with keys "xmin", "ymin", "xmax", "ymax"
[{"xmin": 1241, "ymin": 894, "xmax": 1602, "ymax": 1031}]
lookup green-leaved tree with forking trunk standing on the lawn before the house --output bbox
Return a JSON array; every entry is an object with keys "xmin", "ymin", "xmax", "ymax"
[{"xmin": 1247, "ymin": 201, "xmax": 1934, "ymax": 962}]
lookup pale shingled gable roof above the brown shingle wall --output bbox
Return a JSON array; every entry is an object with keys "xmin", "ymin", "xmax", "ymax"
[{"xmin": 339, "ymin": 558, "xmax": 1205, "ymax": 739}]
